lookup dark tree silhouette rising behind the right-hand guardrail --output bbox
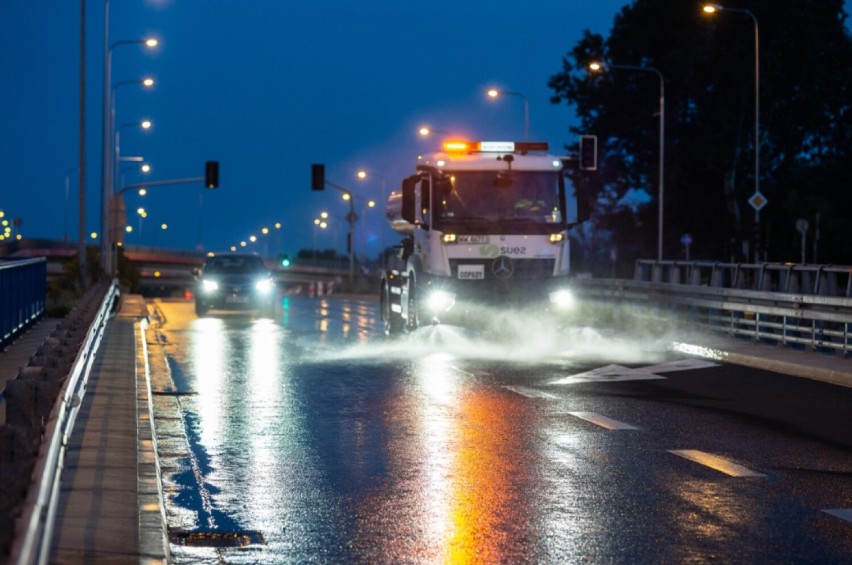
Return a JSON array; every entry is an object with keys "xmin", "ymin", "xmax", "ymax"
[{"xmin": 548, "ymin": 0, "xmax": 852, "ymax": 270}]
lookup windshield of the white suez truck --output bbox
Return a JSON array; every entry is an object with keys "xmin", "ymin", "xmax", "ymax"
[{"xmin": 435, "ymin": 171, "xmax": 563, "ymax": 229}]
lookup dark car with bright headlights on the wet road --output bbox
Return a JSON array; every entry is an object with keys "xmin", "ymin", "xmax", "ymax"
[{"xmin": 195, "ymin": 253, "xmax": 275, "ymax": 316}]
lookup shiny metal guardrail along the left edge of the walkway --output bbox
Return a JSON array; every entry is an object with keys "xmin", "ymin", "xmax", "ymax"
[{"xmin": 9, "ymin": 281, "xmax": 119, "ymax": 565}]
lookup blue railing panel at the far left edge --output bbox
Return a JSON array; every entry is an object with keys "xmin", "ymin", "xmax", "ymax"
[{"xmin": 0, "ymin": 257, "xmax": 47, "ymax": 348}]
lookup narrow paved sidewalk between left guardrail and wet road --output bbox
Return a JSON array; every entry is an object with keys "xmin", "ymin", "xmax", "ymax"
[{"xmin": 50, "ymin": 296, "xmax": 168, "ymax": 564}]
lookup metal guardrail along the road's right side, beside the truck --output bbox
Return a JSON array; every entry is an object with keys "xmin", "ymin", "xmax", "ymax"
[{"xmin": 575, "ymin": 260, "xmax": 852, "ymax": 357}]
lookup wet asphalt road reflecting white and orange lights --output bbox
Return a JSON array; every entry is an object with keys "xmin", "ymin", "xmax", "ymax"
[{"xmin": 149, "ymin": 298, "xmax": 852, "ymax": 563}]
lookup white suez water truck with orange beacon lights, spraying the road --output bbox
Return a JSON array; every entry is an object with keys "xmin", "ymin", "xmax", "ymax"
[{"xmin": 381, "ymin": 142, "xmax": 581, "ymax": 334}]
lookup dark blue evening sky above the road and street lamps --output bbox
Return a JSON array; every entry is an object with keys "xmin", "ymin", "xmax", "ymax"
[{"xmin": 5, "ymin": 0, "xmax": 844, "ymax": 255}]
